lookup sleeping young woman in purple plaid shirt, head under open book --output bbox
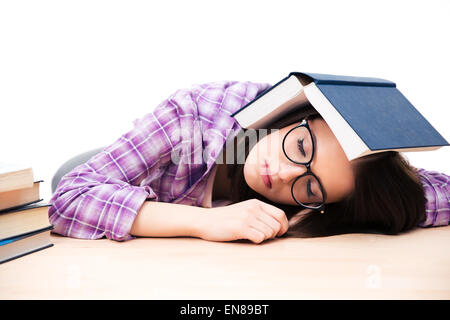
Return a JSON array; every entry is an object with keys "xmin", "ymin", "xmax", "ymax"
[{"xmin": 49, "ymin": 81, "xmax": 450, "ymax": 243}]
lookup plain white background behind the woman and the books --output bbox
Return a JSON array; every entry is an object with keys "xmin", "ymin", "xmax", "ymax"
[{"xmin": 0, "ymin": 0, "xmax": 450, "ymax": 199}]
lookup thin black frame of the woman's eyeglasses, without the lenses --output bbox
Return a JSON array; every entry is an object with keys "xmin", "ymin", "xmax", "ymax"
[{"xmin": 282, "ymin": 118, "xmax": 326, "ymax": 213}]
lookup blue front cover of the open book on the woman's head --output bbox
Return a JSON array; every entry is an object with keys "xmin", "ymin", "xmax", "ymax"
[{"xmin": 298, "ymin": 72, "xmax": 448, "ymax": 151}]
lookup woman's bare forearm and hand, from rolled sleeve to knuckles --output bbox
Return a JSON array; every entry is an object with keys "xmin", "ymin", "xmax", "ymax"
[{"xmin": 130, "ymin": 199, "xmax": 288, "ymax": 243}]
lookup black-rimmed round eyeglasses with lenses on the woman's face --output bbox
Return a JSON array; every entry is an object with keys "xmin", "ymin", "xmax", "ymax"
[{"xmin": 282, "ymin": 119, "xmax": 326, "ymax": 213}]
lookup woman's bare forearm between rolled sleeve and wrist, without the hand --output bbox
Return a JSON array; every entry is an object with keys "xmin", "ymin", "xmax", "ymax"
[{"xmin": 130, "ymin": 201, "xmax": 208, "ymax": 237}]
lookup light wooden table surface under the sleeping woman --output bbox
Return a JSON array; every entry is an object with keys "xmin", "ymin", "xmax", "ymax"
[{"xmin": 0, "ymin": 226, "xmax": 450, "ymax": 300}]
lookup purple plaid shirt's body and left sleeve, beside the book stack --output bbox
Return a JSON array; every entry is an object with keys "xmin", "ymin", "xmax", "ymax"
[{"xmin": 49, "ymin": 81, "xmax": 270, "ymax": 241}]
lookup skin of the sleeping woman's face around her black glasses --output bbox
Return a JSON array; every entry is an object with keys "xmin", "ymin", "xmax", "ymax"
[{"xmin": 244, "ymin": 118, "xmax": 354, "ymax": 205}]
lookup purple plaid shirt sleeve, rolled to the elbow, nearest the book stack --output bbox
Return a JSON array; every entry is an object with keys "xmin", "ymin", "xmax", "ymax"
[{"xmin": 49, "ymin": 100, "xmax": 179, "ymax": 241}]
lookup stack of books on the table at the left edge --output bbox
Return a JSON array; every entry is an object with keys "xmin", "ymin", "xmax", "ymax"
[{"xmin": 0, "ymin": 163, "xmax": 53, "ymax": 264}]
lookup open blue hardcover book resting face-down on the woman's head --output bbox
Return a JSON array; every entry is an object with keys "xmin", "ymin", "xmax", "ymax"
[{"xmin": 232, "ymin": 72, "xmax": 449, "ymax": 160}]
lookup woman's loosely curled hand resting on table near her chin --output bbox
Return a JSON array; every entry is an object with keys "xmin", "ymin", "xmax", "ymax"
[{"xmin": 198, "ymin": 199, "xmax": 288, "ymax": 243}]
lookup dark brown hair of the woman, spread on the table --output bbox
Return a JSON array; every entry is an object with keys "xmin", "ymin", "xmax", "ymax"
[{"xmin": 227, "ymin": 108, "xmax": 426, "ymax": 237}]
